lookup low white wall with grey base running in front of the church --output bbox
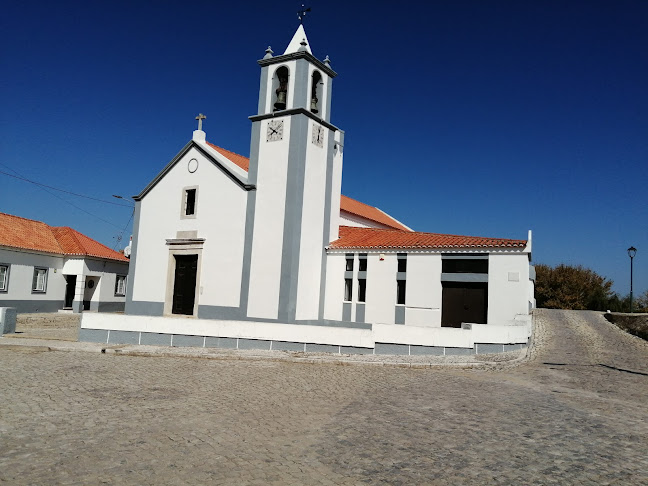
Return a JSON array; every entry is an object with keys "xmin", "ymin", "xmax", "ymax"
[{"xmin": 79, "ymin": 314, "xmax": 531, "ymax": 356}]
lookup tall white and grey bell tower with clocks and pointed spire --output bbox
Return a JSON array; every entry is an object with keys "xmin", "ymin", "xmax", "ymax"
[{"xmin": 241, "ymin": 25, "xmax": 344, "ymax": 323}]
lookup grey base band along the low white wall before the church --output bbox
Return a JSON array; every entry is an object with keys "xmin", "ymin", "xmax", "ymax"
[{"xmin": 79, "ymin": 329, "xmax": 527, "ymax": 356}]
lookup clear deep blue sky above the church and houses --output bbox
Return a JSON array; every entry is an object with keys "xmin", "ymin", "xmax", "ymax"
[{"xmin": 0, "ymin": 0, "xmax": 648, "ymax": 294}]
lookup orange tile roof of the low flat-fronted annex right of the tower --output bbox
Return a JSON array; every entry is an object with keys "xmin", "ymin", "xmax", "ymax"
[{"xmin": 329, "ymin": 226, "xmax": 527, "ymax": 249}]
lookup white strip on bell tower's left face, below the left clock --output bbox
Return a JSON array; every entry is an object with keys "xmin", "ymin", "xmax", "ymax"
[{"xmin": 248, "ymin": 115, "xmax": 294, "ymax": 319}]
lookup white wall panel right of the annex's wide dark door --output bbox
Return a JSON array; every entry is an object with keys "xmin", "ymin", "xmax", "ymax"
[{"xmin": 487, "ymin": 253, "xmax": 529, "ymax": 325}]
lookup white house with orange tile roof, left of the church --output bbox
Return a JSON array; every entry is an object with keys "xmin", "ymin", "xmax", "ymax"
[{"xmin": 0, "ymin": 213, "xmax": 129, "ymax": 313}]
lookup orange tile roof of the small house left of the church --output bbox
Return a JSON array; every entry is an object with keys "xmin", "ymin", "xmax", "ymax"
[{"xmin": 0, "ymin": 213, "xmax": 128, "ymax": 262}]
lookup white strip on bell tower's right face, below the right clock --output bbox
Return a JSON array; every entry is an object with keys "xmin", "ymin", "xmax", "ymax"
[{"xmin": 295, "ymin": 121, "xmax": 331, "ymax": 319}]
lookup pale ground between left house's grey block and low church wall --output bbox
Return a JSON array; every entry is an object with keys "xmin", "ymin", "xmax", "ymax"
[{"xmin": 7, "ymin": 312, "xmax": 81, "ymax": 341}]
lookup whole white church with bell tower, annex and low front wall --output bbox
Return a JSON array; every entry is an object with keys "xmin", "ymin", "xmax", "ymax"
[{"xmin": 79, "ymin": 26, "xmax": 534, "ymax": 354}]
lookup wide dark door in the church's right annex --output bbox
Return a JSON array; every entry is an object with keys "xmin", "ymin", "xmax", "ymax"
[{"xmin": 441, "ymin": 282, "xmax": 488, "ymax": 327}]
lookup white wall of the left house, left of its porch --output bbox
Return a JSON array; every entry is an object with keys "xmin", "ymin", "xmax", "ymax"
[{"xmin": 0, "ymin": 248, "xmax": 65, "ymax": 307}]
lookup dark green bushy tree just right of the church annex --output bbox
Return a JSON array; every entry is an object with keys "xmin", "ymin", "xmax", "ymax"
[{"xmin": 535, "ymin": 264, "xmax": 619, "ymax": 310}]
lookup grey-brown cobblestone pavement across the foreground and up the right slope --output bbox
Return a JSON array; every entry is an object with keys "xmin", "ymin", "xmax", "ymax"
[{"xmin": 0, "ymin": 310, "xmax": 648, "ymax": 485}]
